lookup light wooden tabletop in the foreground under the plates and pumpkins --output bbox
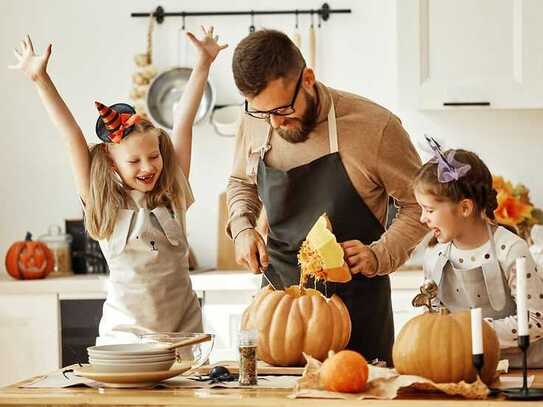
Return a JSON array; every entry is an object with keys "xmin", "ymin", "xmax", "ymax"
[{"xmin": 0, "ymin": 369, "xmax": 543, "ymax": 407}]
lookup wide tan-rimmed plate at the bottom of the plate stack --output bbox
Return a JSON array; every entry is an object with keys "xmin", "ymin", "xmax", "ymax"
[{"xmin": 74, "ymin": 364, "xmax": 190, "ymax": 388}]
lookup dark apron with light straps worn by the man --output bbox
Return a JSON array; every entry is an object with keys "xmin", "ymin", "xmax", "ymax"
[{"xmin": 257, "ymin": 101, "xmax": 394, "ymax": 365}]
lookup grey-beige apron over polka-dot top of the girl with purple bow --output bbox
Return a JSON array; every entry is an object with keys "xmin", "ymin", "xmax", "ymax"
[{"xmin": 426, "ymin": 225, "xmax": 543, "ymax": 368}]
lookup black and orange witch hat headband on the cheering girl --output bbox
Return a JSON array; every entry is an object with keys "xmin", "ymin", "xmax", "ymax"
[{"xmin": 94, "ymin": 102, "xmax": 141, "ymax": 143}]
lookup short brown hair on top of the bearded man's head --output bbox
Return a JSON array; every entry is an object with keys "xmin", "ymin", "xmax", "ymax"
[{"xmin": 232, "ymin": 30, "xmax": 305, "ymax": 97}]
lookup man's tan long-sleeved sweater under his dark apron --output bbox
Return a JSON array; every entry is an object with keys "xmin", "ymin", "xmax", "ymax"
[{"xmin": 227, "ymin": 83, "xmax": 427, "ymax": 275}]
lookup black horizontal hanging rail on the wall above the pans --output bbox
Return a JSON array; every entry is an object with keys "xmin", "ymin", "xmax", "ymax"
[{"xmin": 130, "ymin": 3, "xmax": 351, "ymax": 24}]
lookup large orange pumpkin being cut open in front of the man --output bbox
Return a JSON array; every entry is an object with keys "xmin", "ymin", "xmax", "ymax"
[{"xmin": 241, "ymin": 286, "xmax": 351, "ymax": 366}]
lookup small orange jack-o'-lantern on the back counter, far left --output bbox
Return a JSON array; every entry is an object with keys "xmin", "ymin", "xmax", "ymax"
[{"xmin": 6, "ymin": 233, "xmax": 54, "ymax": 280}]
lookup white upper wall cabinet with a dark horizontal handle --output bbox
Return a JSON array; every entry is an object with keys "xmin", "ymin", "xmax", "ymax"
[{"xmin": 396, "ymin": 0, "xmax": 543, "ymax": 109}]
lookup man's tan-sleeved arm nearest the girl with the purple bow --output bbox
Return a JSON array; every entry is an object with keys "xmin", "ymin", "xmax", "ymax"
[{"xmin": 370, "ymin": 116, "xmax": 428, "ymax": 275}]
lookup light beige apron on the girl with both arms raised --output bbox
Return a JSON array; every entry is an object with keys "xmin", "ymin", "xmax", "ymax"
[{"xmin": 96, "ymin": 191, "xmax": 202, "ymax": 344}]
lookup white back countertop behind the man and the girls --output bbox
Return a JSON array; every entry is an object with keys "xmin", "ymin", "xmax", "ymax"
[{"xmin": 0, "ymin": 270, "xmax": 423, "ymax": 298}]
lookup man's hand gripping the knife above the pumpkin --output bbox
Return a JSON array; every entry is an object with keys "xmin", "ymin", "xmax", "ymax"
[{"xmin": 234, "ymin": 229, "xmax": 268, "ymax": 273}]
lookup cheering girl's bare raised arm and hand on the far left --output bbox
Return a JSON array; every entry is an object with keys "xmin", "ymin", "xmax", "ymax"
[{"xmin": 8, "ymin": 35, "xmax": 90, "ymax": 201}]
